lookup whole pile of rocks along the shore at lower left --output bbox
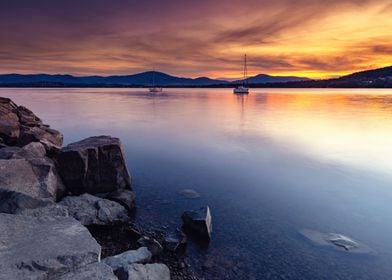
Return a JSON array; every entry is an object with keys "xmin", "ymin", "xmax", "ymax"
[{"xmin": 0, "ymin": 97, "xmax": 212, "ymax": 280}]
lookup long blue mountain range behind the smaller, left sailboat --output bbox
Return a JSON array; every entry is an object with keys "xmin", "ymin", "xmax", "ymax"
[{"xmin": 0, "ymin": 71, "xmax": 229, "ymax": 86}]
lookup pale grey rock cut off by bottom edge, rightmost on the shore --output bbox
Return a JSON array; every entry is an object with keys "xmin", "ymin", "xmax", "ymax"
[{"xmin": 116, "ymin": 263, "xmax": 170, "ymax": 280}]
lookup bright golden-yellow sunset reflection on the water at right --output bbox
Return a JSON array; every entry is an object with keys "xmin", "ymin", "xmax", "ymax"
[{"xmin": 230, "ymin": 90, "xmax": 392, "ymax": 172}]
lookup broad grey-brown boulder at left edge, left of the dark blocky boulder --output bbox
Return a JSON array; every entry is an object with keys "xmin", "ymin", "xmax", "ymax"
[{"xmin": 0, "ymin": 158, "xmax": 65, "ymax": 213}]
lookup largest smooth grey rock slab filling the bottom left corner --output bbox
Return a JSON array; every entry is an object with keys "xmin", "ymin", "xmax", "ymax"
[{"xmin": 0, "ymin": 214, "xmax": 101, "ymax": 280}]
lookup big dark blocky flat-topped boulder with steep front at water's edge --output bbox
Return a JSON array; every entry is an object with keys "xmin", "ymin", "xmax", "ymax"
[{"xmin": 57, "ymin": 136, "xmax": 131, "ymax": 194}]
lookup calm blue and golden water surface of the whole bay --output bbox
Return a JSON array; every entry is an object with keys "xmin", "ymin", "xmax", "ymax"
[{"xmin": 0, "ymin": 89, "xmax": 392, "ymax": 280}]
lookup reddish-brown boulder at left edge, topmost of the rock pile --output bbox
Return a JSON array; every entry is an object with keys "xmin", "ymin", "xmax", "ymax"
[{"xmin": 0, "ymin": 97, "xmax": 20, "ymax": 145}]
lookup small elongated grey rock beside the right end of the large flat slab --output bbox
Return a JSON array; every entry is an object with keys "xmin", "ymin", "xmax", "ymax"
[{"xmin": 102, "ymin": 247, "xmax": 152, "ymax": 271}]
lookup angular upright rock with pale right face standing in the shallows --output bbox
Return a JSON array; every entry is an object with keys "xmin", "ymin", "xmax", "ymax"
[{"xmin": 181, "ymin": 206, "xmax": 212, "ymax": 240}]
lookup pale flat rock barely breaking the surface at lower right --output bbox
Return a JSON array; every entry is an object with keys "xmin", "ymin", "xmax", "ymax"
[{"xmin": 300, "ymin": 229, "xmax": 374, "ymax": 254}]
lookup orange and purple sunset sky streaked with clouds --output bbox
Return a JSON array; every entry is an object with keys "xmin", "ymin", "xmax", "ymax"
[{"xmin": 0, "ymin": 0, "xmax": 392, "ymax": 79}]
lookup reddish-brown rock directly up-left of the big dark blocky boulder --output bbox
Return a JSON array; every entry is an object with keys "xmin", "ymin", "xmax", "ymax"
[{"xmin": 18, "ymin": 125, "xmax": 63, "ymax": 155}]
